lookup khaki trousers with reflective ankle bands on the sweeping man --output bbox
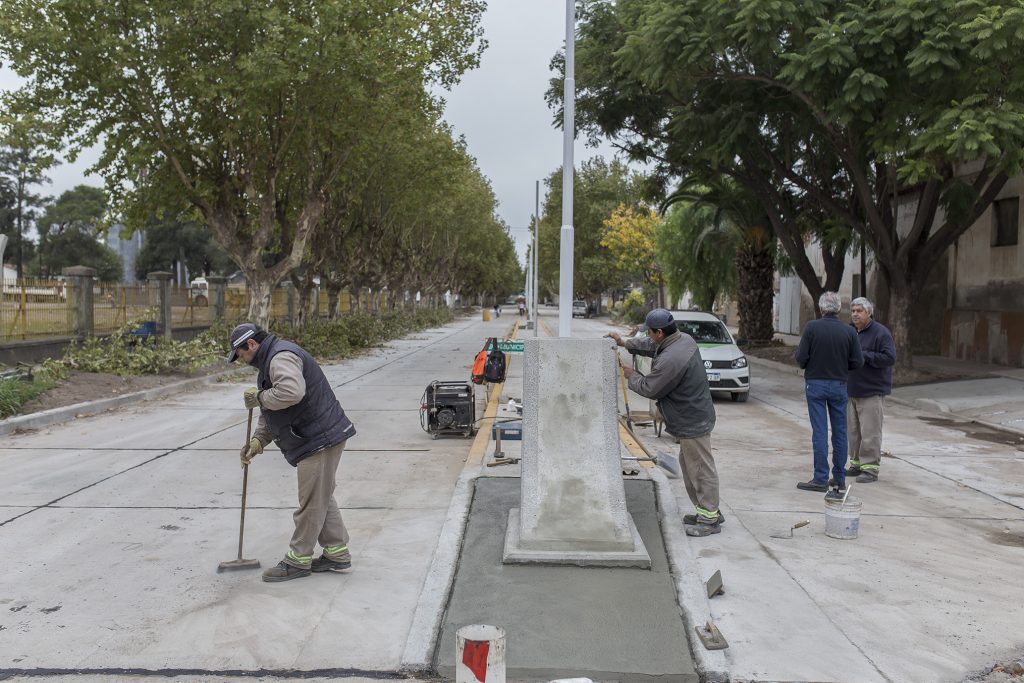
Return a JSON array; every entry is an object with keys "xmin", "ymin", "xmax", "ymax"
[{"xmin": 285, "ymin": 441, "xmax": 348, "ymax": 568}]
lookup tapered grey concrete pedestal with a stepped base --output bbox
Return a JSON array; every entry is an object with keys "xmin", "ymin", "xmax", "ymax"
[{"xmin": 503, "ymin": 339, "xmax": 650, "ymax": 567}]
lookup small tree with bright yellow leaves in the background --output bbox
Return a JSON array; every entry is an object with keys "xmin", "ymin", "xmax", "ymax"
[{"xmin": 600, "ymin": 204, "xmax": 666, "ymax": 307}]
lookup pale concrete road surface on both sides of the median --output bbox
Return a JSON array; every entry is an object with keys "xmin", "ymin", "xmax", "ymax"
[{"xmin": 0, "ymin": 307, "xmax": 1024, "ymax": 683}]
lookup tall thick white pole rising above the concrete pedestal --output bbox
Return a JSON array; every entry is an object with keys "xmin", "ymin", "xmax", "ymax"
[{"xmin": 558, "ymin": 0, "xmax": 575, "ymax": 337}]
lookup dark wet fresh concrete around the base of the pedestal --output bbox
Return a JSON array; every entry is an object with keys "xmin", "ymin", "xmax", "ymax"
[{"xmin": 438, "ymin": 477, "xmax": 697, "ymax": 683}]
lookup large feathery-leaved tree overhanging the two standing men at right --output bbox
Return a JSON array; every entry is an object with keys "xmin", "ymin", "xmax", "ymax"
[{"xmin": 565, "ymin": 0, "xmax": 1024, "ymax": 366}]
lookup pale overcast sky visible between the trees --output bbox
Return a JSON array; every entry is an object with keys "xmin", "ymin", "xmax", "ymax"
[{"xmin": 0, "ymin": 0, "xmax": 613, "ymax": 266}]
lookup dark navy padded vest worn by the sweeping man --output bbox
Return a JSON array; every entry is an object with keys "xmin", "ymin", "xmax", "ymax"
[{"xmin": 253, "ymin": 335, "xmax": 355, "ymax": 467}]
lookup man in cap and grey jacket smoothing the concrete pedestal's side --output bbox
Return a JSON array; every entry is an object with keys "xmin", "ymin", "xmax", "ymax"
[{"xmin": 606, "ymin": 308, "xmax": 725, "ymax": 536}]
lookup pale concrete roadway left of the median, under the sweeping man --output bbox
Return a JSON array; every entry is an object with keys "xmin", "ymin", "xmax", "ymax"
[{"xmin": 0, "ymin": 316, "xmax": 512, "ymax": 678}]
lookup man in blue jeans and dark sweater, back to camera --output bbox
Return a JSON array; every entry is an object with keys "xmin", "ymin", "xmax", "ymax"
[{"xmin": 794, "ymin": 292, "xmax": 864, "ymax": 498}]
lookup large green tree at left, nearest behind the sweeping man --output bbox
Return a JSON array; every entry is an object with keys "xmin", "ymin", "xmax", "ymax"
[{"xmin": 0, "ymin": 0, "xmax": 483, "ymax": 324}]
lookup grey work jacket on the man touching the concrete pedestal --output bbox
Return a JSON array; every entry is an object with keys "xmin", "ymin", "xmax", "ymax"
[{"xmin": 626, "ymin": 332, "xmax": 715, "ymax": 438}]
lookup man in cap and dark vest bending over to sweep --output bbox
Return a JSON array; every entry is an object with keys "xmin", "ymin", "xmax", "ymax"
[{"xmin": 227, "ymin": 323, "xmax": 355, "ymax": 582}]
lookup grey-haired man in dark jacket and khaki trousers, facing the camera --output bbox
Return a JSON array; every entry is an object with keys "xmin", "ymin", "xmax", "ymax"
[{"xmin": 846, "ymin": 297, "xmax": 896, "ymax": 483}]
